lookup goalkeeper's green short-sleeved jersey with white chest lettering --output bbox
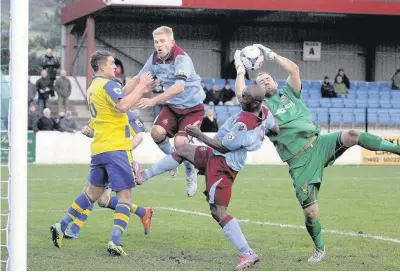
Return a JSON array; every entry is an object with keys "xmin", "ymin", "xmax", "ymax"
[{"xmin": 265, "ymin": 84, "xmax": 321, "ymax": 161}]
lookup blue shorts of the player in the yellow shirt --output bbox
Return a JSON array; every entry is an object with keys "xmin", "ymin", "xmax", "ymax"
[{"xmin": 88, "ymin": 150, "xmax": 135, "ymax": 192}]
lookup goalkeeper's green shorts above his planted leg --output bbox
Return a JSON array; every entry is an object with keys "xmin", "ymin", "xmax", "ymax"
[{"xmin": 287, "ymin": 132, "xmax": 347, "ymax": 206}]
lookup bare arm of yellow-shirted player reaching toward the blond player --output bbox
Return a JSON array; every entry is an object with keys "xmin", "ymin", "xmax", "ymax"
[{"xmin": 116, "ymin": 72, "xmax": 154, "ymax": 112}]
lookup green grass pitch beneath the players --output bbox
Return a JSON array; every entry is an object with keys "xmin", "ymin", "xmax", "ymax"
[{"xmin": 2, "ymin": 165, "xmax": 400, "ymax": 270}]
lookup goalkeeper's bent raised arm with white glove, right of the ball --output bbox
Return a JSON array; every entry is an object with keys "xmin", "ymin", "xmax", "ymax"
[{"xmin": 254, "ymin": 44, "xmax": 301, "ymax": 92}]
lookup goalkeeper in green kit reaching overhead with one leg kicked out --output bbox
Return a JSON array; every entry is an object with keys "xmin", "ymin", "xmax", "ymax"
[{"xmin": 235, "ymin": 44, "xmax": 400, "ymax": 263}]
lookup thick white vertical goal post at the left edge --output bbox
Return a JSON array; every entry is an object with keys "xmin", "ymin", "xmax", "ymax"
[{"xmin": 7, "ymin": 0, "xmax": 29, "ymax": 271}]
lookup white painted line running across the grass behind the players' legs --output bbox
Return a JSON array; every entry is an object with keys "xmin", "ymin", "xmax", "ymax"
[{"xmin": 155, "ymin": 207, "xmax": 400, "ymax": 243}]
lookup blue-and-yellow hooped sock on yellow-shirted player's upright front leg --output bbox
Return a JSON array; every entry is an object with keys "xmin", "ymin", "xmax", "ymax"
[{"xmin": 111, "ymin": 202, "xmax": 132, "ymax": 246}]
